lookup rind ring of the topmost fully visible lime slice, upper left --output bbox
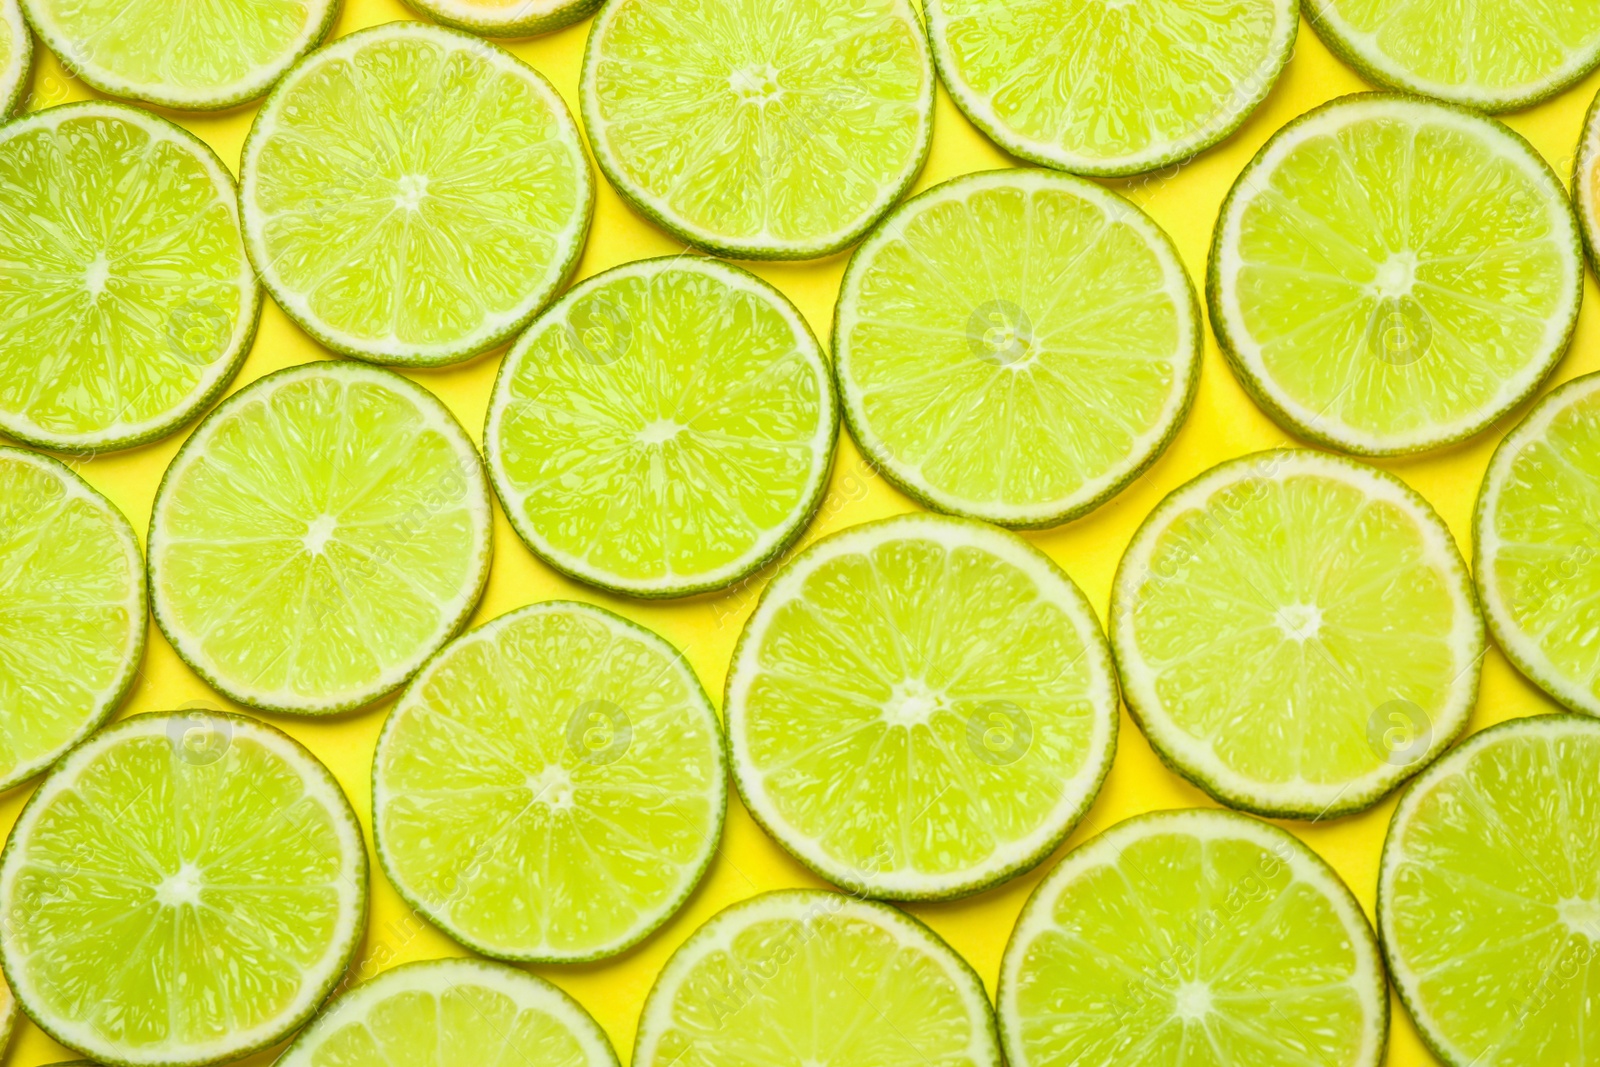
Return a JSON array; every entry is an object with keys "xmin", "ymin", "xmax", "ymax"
[{"xmin": 238, "ymin": 21, "xmax": 595, "ymax": 368}]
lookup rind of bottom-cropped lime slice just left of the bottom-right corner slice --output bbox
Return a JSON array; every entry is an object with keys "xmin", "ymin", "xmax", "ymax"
[{"xmin": 995, "ymin": 808, "xmax": 1389, "ymax": 1067}]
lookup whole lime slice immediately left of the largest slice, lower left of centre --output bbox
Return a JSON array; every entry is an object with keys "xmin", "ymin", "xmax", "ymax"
[{"xmin": 373, "ymin": 601, "xmax": 728, "ymax": 963}]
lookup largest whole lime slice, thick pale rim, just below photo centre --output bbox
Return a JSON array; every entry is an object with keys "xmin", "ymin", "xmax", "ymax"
[{"xmin": 723, "ymin": 515, "xmax": 1117, "ymax": 901}]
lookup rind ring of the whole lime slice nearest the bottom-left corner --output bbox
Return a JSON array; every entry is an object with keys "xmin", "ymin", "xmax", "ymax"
[{"xmin": 0, "ymin": 712, "xmax": 368, "ymax": 1067}]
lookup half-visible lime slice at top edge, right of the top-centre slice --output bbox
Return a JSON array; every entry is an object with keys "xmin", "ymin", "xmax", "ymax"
[{"xmin": 925, "ymin": 0, "xmax": 1299, "ymax": 176}]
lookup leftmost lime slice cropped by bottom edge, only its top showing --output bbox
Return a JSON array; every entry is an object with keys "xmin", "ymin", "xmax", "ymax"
[{"xmin": 275, "ymin": 960, "xmax": 616, "ymax": 1067}]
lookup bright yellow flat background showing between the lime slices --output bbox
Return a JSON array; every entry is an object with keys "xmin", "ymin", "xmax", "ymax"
[{"xmin": 0, "ymin": 0, "xmax": 1600, "ymax": 1067}]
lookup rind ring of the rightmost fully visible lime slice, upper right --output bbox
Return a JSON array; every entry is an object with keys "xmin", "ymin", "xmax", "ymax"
[{"xmin": 1206, "ymin": 93, "xmax": 1584, "ymax": 458}]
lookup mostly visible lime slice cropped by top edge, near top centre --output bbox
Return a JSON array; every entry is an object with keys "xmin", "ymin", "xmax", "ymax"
[{"xmin": 581, "ymin": 0, "xmax": 933, "ymax": 259}]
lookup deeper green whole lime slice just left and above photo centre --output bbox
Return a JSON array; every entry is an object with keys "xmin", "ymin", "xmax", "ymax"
[{"xmin": 483, "ymin": 256, "xmax": 838, "ymax": 597}]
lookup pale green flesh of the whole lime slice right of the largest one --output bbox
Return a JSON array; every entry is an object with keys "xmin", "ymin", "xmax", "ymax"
[{"xmin": 1128, "ymin": 475, "xmax": 1464, "ymax": 784}]
